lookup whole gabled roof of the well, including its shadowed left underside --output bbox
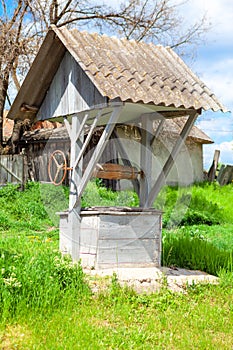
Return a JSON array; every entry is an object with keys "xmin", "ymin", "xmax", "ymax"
[{"xmin": 9, "ymin": 26, "xmax": 227, "ymax": 119}]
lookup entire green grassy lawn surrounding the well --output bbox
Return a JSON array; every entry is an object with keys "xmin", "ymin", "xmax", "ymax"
[{"xmin": 0, "ymin": 183, "xmax": 233, "ymax": 350}]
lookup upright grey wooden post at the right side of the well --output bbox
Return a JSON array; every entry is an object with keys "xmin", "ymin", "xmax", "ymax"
[{"xmin": 139, "ymin": 117, "xmax": 153, "ymax": 207}]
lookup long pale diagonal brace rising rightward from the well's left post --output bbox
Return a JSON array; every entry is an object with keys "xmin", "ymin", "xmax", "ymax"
[{"xmin": 74, "ymin": 106, "xmax": 123, "ymax": 207}]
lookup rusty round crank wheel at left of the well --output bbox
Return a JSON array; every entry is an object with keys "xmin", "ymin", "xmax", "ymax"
[{"xmin": 48, "ymin": 150, "xmax": 68, "ymax": 186}]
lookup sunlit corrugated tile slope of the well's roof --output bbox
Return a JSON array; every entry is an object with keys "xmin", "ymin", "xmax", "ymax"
[{"xmin": 56, "ymin": 28, "xmax": 226, "ymax": 111}]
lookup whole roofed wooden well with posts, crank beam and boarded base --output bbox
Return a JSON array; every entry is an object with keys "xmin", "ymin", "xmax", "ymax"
[{"xmin": 8, "ymin": 27, "xmax": 225, "ymax": 268}]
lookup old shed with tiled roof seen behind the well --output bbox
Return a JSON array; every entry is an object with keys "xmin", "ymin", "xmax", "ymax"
[{"xmin": 18, "ymin": 117, "xmax": 213, "ymax": 190}]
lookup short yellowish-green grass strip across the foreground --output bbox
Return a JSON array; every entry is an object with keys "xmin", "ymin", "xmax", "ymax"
[{"xmin": 0, "ymin": 274, "xmax": 233, "ymax": 350}]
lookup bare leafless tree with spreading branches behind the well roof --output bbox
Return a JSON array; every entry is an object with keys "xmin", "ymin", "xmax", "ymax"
[{"xmin": 0, "ymin": 0, "xmax": 209, "ymax": 149}]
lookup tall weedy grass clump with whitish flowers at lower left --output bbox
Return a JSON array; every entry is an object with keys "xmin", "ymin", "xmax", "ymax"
[{"xmin": 0, "ymin": 234, "xmax": 89, "ymax": 319}]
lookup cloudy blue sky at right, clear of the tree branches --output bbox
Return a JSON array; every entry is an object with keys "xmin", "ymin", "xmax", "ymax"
[{"xmin": 180, "ymin": 0, "xmax": 233, "ymax": 170}]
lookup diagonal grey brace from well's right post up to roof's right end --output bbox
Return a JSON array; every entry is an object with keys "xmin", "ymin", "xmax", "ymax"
[{"xmin": 144, "ymin": 113, "xmax": 199, "ymax": 208}]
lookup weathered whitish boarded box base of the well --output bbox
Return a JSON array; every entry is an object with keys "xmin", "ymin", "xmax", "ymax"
[{"xmin": 60, "ymin": 207, "xmax": 162, "ymax": 269}]
